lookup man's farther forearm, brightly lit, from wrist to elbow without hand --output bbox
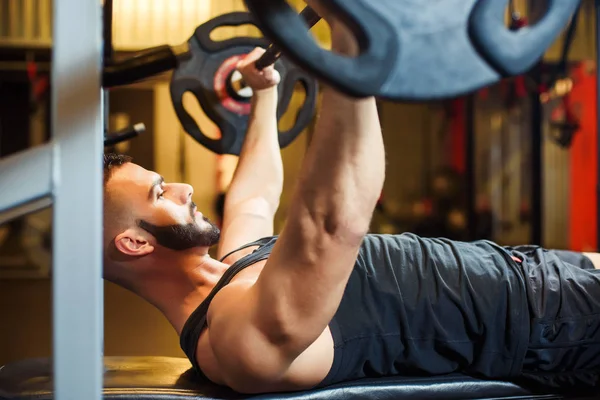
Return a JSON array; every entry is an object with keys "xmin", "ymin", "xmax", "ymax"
[{"xmin": 225, "ymin": 87, "xmax": 283, "ymax": 208}]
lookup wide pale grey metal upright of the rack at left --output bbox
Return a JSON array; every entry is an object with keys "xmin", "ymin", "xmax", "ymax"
[{"xmin": 51, "ymin": 0, "xmax": 103, "ymax": 400}]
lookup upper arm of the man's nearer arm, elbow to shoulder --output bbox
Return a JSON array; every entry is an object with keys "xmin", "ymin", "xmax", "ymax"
[{"xmin": 248, "ymin": 221, "xmax": 360, "ymax": 358}]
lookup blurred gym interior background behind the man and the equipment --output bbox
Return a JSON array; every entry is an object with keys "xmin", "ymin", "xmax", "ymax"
[{"xmin": 0, "ymin": 0, "xmax": 599, "ymax": 400}]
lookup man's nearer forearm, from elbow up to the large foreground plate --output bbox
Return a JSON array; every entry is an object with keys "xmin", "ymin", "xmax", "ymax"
[{"xmin": 286, "ymin": 28, "xmax": 385, "ymax": 241}]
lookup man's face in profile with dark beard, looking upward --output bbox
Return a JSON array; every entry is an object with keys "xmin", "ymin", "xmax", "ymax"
[{"xmin": 107, "ymin": 163, "xmax": 220, "ymax": 250}]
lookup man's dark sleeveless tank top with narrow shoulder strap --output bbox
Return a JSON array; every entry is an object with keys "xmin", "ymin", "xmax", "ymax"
[{"xmin": 180, "ymin": 234, "xmax": 529, "ymax": 387}]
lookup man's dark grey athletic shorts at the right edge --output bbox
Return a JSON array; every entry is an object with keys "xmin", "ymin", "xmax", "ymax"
[{"xmin": 508, "ymin": 246, "xmax": 600, "ymax": 388}]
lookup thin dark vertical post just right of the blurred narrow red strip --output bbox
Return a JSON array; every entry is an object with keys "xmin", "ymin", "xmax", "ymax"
[{"xmin": 464, "ymin": 94, "xmax": 478, "ymax": 240}]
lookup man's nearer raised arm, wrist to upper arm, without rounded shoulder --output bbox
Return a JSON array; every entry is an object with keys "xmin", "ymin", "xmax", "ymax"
[{"xmin": 254, "ymin": 36, "xmax": 385, "ymax": 359}]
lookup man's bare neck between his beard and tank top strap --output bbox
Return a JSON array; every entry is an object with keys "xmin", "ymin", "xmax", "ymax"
[{"xmin": 136, "ymin": 255, "xmax": 229, "ymax": 334}]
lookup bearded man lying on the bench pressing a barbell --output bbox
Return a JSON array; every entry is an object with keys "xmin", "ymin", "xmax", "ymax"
[{"xmin": 104, "ymin": 3, "xmax": 600, "ymax": 393}]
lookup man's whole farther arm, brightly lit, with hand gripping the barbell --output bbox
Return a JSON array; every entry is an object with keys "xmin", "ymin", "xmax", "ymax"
[{"xmin": 218, "ymin": 48, "xmax": 283, "ymax": 262}]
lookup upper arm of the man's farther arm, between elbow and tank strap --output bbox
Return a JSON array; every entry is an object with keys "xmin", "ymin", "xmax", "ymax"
[{"xmin": 218, "ymin": 199, "xmax": 275, "ymax": 262}]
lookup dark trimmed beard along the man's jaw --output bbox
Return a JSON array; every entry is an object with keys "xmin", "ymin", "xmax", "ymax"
[{"xmin": 138, "ymin": 202, "xmax": 221, "ymax": 251}]
